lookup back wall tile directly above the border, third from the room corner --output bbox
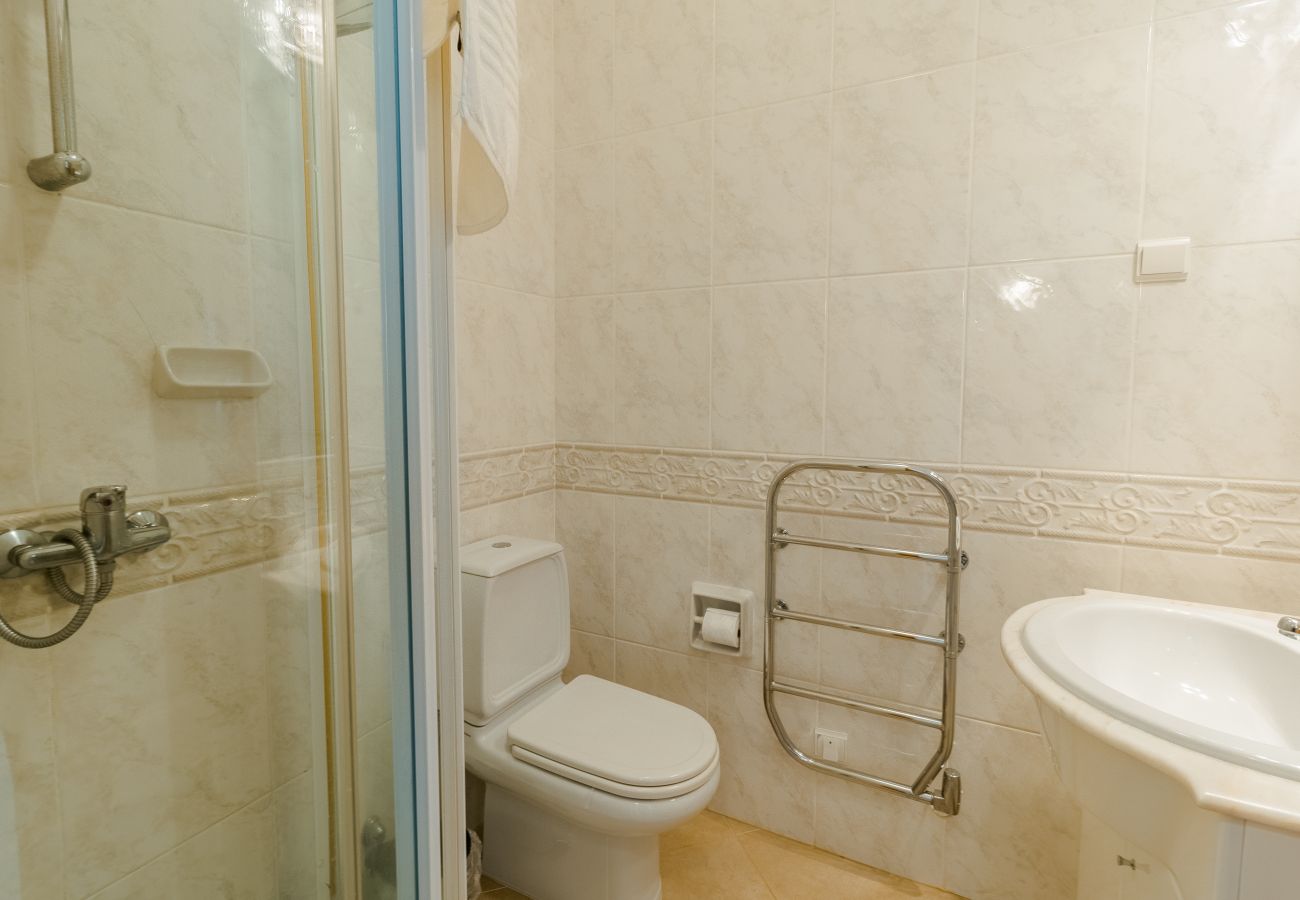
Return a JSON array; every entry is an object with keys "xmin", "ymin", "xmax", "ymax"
[{"xmin": 710, "ymin": 281, "xmax": 827, "ymax": 454}]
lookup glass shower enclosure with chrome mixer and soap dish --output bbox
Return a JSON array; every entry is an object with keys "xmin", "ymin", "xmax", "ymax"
[{"xmin": 0, "ymin": 0, "xmax": 437, "ymax": 900}]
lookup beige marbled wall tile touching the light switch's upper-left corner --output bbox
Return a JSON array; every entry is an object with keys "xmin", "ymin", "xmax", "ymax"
[{"xmin": 971, "ymin": 27, "xmax": 1148, "ymax": 263}]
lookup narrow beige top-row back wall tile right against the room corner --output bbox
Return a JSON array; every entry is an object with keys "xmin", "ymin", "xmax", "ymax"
[{"xmin": 555, "ymin": 0, "xmax": 614, "ymax": 147}]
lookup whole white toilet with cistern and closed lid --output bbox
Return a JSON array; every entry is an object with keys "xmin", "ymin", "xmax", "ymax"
[{"xmin": 460, "ymin": 536, "xmax": 719, "ymax": 900}]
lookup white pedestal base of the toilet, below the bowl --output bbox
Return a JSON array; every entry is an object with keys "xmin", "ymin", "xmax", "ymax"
[{"xmin": 484, "ymin": 783, "xmax": 662, "ymax": 900}]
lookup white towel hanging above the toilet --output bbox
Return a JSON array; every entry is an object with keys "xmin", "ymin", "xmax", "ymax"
[{"xmin": 456, "ymin": 0, "xmax": 519, "ymax": 234}]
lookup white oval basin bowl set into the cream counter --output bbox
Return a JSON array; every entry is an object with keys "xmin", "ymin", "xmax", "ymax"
[{"xmin": 1023, "ymin": 596, "xmax": 1300, "ymax": 780}]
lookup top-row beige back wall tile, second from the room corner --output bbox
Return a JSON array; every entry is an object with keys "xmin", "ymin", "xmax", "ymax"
[{"xmin": 614, "ymin": 0, "xmax": 714, "ymax": 134}]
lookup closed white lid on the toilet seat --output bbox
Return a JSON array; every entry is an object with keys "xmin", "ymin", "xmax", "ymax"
[{"xmin": 507, "ymin": 675, "xmax": 718, "ymax": 797}]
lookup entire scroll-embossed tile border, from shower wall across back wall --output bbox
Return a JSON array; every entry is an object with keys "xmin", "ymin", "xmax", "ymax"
[{"xmin": 0, "ymin": 443, "xmax": 1300, "ymax": 618}]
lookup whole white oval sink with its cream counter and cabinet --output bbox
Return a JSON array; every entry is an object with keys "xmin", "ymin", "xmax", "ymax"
[{"xmin": 1002, "ymin": 590, "xmax": 1300, "ymax": 900}]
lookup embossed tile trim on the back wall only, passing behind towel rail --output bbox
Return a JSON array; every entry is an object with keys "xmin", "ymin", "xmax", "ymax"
[{"xmin": 555, "ymin": 443, "xmax": 1300, "ymax": 559}]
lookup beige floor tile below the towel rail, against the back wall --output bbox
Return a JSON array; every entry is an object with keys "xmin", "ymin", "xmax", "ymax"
[{"xmin": 738, "ymin": 831, "xmax": 953, "ymax": 900}]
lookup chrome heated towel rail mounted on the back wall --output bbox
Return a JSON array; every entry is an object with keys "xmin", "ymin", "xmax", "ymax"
[{"xmin": 763, "ymin": 459, "xmax": 969, "ymax": 815}]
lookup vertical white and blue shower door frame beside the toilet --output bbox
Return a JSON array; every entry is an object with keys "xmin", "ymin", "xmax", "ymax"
[{"xmin": 373, "ymin": 0, "xmax": 467, "ymax": 900}]
